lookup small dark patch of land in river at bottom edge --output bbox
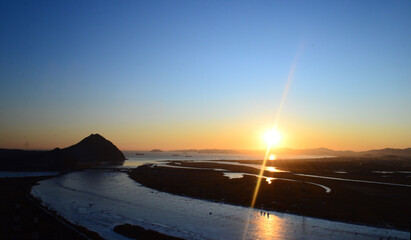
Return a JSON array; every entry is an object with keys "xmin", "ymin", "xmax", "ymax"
[{"xmin": 114, "ymin": 224, "xmax": 183, "ymax": 240}]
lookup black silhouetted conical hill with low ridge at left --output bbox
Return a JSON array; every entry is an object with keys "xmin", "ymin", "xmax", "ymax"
[{"xmin": 0, "ymin": 134, "xmax": 126, "ymax": 171}]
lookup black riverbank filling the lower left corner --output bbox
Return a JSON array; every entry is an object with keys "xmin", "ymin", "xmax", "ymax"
[{"xmin": 0, "ymin": 177, "xmax": 101, "ymax": 240}]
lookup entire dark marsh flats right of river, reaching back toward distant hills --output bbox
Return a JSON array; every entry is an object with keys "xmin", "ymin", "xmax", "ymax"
[{"xmin": 130, "ymin": 158, "xmax": 411, "ymax": 230}]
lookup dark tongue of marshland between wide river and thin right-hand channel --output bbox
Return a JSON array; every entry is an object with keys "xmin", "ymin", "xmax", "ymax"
[{"xmin": 129, "ymin": 160, "xmax": 411, "ymax": 231}]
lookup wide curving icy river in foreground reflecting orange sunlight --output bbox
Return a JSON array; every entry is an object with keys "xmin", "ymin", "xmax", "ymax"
[{"xmin": 32, "ymin": 171, "xmax": 409, "ymax": 240}]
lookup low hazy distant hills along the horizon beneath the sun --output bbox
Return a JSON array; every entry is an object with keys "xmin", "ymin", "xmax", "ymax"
[{"xmin": 173, "ymin": 148, "xmax": 411, "ymax": 157}]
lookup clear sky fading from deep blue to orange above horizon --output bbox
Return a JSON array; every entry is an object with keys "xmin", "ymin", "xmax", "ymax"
[{"xmin": 0, "ymin": 0, "xmax": 411, "ymax": 150}]
